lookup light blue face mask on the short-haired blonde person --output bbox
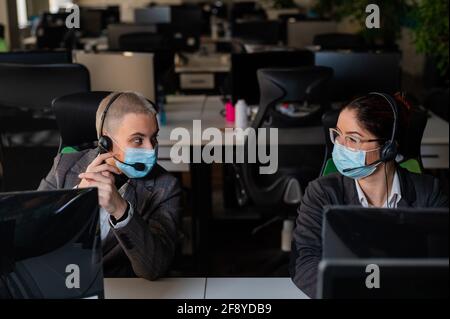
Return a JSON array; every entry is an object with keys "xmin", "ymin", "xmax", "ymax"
[{"xmin": 116, "ymin": 147, "xmax": 158, "ymax": 178}]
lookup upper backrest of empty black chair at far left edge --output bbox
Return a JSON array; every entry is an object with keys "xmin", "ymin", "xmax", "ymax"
[{"xmin": 0, "ymin": 64, "xmax": 90, "ymax": 110}]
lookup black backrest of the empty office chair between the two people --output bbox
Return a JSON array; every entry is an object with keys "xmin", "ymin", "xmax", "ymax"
[{"xmin": 252, "ymin": 66, "xmax": 333, "ymax": 128}]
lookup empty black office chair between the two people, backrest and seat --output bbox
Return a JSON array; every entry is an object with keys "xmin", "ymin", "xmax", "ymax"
[{"xmin": 230, "ymin": 67, "xmax": 333, "ymax": 220}]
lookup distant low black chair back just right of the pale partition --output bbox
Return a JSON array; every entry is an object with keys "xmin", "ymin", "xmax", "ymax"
[{"xmin": 313, "ymin": 33, "xmax": 365, "ymax": 51}]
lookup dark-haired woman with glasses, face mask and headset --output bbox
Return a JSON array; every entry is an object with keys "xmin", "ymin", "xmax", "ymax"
[{"xmin": 291, "ymin": 93, "xmax": 448, "ymax": 297}]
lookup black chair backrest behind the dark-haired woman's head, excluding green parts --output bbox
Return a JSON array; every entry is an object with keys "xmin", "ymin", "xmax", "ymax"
[{"xmin": 322, "ymin": 106, "xmax": 428, "ymax": 168}]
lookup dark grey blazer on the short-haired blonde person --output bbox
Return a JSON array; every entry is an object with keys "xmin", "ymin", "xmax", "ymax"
[{"xmin": 39, "ymin": 150, "xmax": 181, "ymax": 280}]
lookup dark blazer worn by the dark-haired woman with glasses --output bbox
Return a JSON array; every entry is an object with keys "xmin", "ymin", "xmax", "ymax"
[{"xmin": 290, "ymin": 168, "xmax": 448, "ymax": 298}]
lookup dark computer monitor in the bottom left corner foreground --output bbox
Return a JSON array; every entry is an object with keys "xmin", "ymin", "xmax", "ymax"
[{"xmin": 0, "ymin": 188, "xmax": 104, "ymax": 299}]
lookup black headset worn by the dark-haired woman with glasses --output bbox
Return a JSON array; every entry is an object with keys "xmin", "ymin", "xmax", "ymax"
[{"xmin": 344, "ymin": 92, "xmax": 398, "ymax": 172}]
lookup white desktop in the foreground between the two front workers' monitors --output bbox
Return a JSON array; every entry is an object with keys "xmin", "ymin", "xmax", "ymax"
[{"xmin": 104, "ymin": 278, "xmax": 308, "ymax": 299}]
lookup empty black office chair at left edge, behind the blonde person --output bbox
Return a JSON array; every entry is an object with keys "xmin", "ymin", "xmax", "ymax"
[{"xmin": 0, "ymin": 64, "xmax": 90, "ymax": 191}]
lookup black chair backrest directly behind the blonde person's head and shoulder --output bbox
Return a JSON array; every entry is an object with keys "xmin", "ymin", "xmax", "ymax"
[{"xmin": 53, "ymin": 91, "xmax": 111, "ymax": 149}]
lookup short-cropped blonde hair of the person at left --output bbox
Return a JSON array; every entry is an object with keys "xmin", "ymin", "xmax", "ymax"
[{"xmin": 95, "ymin": 91, "xmax": 158, "ymax": 137}]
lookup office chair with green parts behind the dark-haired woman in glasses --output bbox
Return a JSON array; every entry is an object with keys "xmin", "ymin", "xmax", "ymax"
[{"xmin": 320, "ymin": 107, "xmax": 428, "ymax": 176}]
